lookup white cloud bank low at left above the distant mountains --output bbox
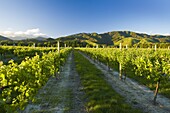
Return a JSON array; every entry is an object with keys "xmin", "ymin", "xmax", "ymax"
[{"xmin": 0, "ymin": 28, "xmax": 48, "ymax": 40}]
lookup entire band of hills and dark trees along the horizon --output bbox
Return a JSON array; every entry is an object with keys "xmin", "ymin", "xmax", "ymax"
[{"xmin": 0, "ymin": 31, "xmax": 170, "ymax": 48}]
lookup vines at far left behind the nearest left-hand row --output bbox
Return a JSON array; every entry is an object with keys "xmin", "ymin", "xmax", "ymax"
[{"xmin": 0, "ymin": 46, "xmax": 57, "ymax": 64}]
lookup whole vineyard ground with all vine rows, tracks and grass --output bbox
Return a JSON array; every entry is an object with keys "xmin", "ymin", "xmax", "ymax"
[{"xmin": 0, "ymin": 46, "xmax": 170, "ymax": 113}]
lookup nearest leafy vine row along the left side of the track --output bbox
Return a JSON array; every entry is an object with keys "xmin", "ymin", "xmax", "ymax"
[{"xmin": 0, "ymin": 49, "xmax": 70, "ymax": 112}]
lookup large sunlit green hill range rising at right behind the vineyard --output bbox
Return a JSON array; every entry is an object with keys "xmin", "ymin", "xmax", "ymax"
[{"xmin": 58, "ymin": 31, "xmax": 170, "ymax": 46}]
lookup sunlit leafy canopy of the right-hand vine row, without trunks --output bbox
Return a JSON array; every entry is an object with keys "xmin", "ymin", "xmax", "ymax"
[{"xmin": 79, "ymin": 48, "xmax": 170, "ymax": 80}]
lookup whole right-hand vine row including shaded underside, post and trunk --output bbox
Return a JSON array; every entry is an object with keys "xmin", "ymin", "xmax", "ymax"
[{"xmin": 80, "ymin": 48, "xmax": 170, "ymax": 102}]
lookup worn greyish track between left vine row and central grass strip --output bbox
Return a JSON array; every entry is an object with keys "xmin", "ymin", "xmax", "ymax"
[{"xmin": 23, "ymin": 53, "xmax": 85, "ymax": 113}]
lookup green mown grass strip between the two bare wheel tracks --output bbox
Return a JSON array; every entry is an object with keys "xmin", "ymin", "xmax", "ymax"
[{"xmin": 74, "ymin": 51, "xmax": 141, "ymax": 113}]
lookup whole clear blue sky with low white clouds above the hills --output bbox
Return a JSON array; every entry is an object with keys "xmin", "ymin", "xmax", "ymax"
[{"xmin": 0, "ymin": 0, "xmax": 170, "ymax": 38}]
